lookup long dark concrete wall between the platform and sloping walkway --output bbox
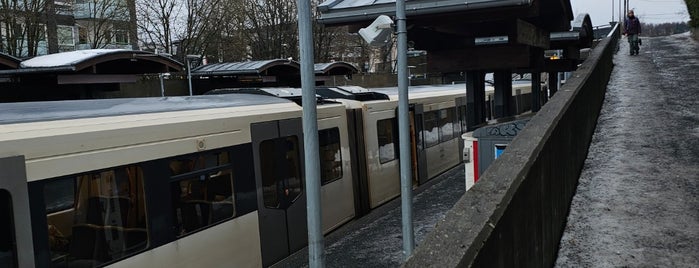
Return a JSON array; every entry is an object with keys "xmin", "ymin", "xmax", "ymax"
[{"xmin": 404, "ymin": 24, "xmax": 619, "ymax": 267}]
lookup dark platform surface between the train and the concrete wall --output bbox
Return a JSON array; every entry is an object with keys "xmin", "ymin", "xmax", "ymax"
[{"xmin": 273, "ymin": 164, "xmax": 465, "ymax": 268}]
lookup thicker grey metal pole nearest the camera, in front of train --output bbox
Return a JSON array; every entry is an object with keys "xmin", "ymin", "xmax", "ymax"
[{"xmin": 298, "ymin": 0, "xmax": 325, "ymax": 268}]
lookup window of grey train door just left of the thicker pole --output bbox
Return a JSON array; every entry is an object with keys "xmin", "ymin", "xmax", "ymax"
[{"xmin": 260, "ymin": 136, "xmax": 302, "ymax": 208}]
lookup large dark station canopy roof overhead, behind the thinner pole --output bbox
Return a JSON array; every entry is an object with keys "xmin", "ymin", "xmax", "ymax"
[{"xmin": 318, "ymin": 0, "xmax": 573, "ymax": 73}]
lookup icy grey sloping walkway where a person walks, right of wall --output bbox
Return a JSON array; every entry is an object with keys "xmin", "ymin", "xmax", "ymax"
[{"xmin": 556, "ymin": 34, "xmax": 699, "ymax": 267}]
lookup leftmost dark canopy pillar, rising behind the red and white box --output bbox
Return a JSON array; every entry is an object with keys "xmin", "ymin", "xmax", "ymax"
[{"xmin": 466, "ymin": 71, "xmax": 485, "ymax": 131}]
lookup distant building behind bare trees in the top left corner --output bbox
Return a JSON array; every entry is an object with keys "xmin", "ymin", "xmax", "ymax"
[{"xmin": 0, "ymin": 0, "xmax": 137, "ymax": 58}]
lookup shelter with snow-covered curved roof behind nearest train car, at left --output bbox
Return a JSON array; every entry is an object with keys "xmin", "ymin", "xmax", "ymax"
[{"xmin": 0, "ymin": 49, "xmax": 183, "ymax": 102}]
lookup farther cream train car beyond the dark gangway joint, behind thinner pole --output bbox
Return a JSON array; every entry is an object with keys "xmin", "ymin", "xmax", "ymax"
[{"xmin": 318, "ymin": 85, "xmax": 466, "ymax": 215}]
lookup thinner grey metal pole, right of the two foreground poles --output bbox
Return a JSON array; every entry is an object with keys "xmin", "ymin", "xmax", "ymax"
[{"xmin": 396, "ymin": 0, "xmax": 415, "ymax": 260}]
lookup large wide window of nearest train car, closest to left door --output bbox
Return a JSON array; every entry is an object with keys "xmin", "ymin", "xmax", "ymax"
[{"xmin": 43, "ymin": 166, "xmax": 148, "ymax": 267}]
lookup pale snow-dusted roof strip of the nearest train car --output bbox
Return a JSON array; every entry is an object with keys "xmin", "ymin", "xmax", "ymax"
[{"xmin": 0, "ymin": 94, "xmax": 293, "ymax": 124}]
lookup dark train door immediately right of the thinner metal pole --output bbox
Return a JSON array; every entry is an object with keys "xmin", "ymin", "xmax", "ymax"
[{"xmin": 409, "ymin": 104, "xmax": 428, "ymax": 186}]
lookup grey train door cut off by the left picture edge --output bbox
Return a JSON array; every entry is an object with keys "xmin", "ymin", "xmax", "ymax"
[{"xmin": 0, "ymin": 156, "xmax": 34, "ymax": 267}]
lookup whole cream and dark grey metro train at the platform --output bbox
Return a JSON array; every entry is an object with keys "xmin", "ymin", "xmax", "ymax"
[{"xmin": 0, "ymin": 82, "xmax": 532, "ymax": 267}]
